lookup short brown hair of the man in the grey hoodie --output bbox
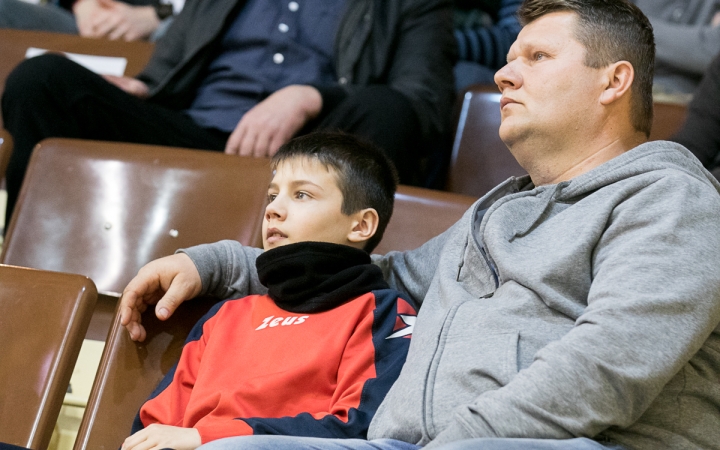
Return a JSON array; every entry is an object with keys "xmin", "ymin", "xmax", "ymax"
[{"xmin": 518, "ymin": 0, "xmax": 655, "ymax": 136}]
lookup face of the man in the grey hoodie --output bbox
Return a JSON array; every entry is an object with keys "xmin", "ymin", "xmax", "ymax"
[{"xmin": 495, "ymin": 12, "xmax": 602, "ymax": 151}]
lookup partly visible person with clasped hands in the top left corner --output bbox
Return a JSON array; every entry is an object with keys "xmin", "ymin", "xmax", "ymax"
[{"xmin": 0, "ymin": 0, "xmax": 179, "ymax": 41}]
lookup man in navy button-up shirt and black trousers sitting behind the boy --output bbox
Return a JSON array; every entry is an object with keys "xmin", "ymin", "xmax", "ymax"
[{"xmin": 2, "ymin": 0, "xmax": 455, "ymax": 217}]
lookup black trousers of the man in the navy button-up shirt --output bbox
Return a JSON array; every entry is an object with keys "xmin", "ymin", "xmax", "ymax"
[{"xmin": 2, "ymin": 54, "xmax": 424, "ymax": 220}]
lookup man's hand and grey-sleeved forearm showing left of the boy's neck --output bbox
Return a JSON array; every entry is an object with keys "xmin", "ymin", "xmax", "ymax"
[{"xmin": 120, "ymin": 241, "xmax": 267, "ymax": 341}]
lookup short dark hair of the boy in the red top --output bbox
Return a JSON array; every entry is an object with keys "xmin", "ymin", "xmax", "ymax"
[{"xmin": 270, "ymin": 131, "xmax": 398, "ymax": 253}]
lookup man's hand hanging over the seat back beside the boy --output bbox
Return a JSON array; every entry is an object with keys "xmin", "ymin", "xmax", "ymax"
[{"xmin": 120, "ymin": 253, "xmax": 202, "ymax": 341}]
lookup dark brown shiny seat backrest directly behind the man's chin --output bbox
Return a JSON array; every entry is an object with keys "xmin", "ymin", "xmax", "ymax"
[{"xmin": 446, "ymin": 85, "xmax": 525, "ymax": 197}]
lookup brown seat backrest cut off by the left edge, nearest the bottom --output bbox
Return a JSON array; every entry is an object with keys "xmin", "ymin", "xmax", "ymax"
[{"xmin": 0, "ymin": 264, "xmax": 97, "ymax": 449}]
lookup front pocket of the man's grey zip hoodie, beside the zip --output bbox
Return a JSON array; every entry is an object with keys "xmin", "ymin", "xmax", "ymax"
[{"xmin": 427, "ymin": 326, "xmax": 519, "ymax": 436}]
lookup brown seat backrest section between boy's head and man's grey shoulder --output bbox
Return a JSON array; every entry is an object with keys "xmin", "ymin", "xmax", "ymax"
[{"xmin": 373, "ymin": 186, "xmax": 476, "ymax": 254}]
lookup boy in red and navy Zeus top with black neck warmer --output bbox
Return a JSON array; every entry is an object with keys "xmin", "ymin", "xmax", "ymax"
[{"xmin": 122, "ymin": 133, "xmax": 416, "ymax": 450}]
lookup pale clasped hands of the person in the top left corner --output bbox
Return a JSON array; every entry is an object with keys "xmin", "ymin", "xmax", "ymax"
[{"xmin": 73, "ymin": 0, "xmax": 160, "ymax": 41}]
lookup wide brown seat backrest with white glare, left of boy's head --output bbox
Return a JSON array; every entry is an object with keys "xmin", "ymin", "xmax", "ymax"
[{"xmin": 0, "ymin": 139, "xmax": 271, "ymax": 293}]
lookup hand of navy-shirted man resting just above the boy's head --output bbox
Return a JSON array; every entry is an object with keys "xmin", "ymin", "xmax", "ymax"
[{"xmin": 225, "ymin": 85, "xmax": 322, "ymax": 156}]
